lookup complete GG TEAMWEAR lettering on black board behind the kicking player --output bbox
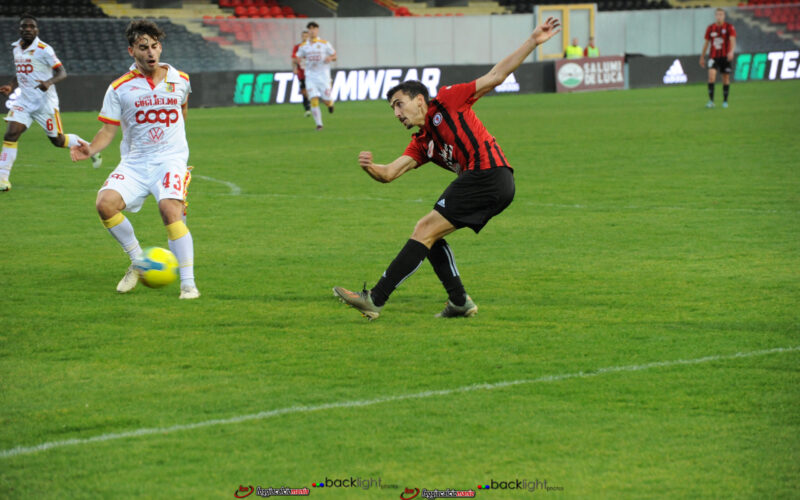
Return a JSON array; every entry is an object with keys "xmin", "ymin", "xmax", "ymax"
[{"xmin": 233, "ymin": 68, "xmax": 442, "ymax": 104}]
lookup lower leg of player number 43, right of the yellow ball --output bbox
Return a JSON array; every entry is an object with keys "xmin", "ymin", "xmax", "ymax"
[{"xmin": 158, "ymin": 198, "xmax": 200, "ymax": 299}]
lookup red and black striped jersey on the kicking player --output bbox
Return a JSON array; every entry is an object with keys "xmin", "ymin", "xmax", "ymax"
[{"xmin": 404, "ymin": 81, "xmax": 511, "ymax": 174}]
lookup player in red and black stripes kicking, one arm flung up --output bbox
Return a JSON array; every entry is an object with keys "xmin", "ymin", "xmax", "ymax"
[{"xmin": 333, "ymin": 18, "xmax": 560, "ymax": 319}]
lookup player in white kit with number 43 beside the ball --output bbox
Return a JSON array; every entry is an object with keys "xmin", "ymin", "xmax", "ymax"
[{"xmin": 70, "ymin": 20, "xmax": 200, "ymax": 299}]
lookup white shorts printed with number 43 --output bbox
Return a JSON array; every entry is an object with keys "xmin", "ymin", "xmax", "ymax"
[{"xmin": 100, "ymin": 159, "xmax": 192, "ymax": 213}]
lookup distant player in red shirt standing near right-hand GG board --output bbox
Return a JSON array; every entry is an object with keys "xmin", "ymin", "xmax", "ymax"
[{"xmin": 700, "ymin": 9, "xmax": 736, "ymax": 108}]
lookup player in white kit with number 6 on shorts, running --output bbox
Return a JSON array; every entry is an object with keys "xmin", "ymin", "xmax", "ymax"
[{"xmin": 0, "ymin": 14, "xmax": 102, "ymax": 191}]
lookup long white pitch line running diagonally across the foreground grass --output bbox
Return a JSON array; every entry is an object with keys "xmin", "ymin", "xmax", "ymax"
[{"xmin": 0, "ymin": 346, "xmax": 800, "ymax": 458}]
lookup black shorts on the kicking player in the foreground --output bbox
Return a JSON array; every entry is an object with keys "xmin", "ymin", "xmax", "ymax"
[{"xmin": 433, "ymin": 167, "xmax": 514, "ymax": 233}]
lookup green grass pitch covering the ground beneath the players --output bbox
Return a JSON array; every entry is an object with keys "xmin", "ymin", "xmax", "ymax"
[{"xmin": 0, "ymin": 82, "xmax": 800, "ymax": 500}]
